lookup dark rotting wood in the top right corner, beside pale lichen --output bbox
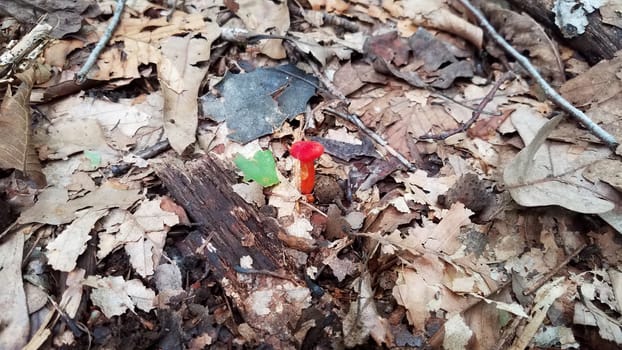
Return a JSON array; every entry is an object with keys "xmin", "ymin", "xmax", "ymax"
[{"xmin": 508, "ymin": 0, "xmax": 622, "ymax": 65}]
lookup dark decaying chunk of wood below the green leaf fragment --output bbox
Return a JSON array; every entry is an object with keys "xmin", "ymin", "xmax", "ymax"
[{"xmin": 155, "ymin": 155, "xmax": 310, "ymax": 347}]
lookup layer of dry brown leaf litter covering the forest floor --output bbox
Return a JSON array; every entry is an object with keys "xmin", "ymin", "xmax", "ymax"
[{"xmin": 0, "ymin": 0, "xmax": 622, "ymax": 349}]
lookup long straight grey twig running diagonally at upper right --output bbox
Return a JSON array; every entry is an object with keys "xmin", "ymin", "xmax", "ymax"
[{"xmin": 458, "ymin": 0, "xmax": 618, "ymax": 149}]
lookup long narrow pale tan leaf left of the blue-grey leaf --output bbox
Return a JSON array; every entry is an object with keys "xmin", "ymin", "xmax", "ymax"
[{"xmin": 158, "ymin": 33, "xmax": 217, "ymax": 154}]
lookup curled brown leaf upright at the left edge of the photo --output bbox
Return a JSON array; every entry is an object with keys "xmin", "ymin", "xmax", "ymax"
[{"xmin": 0, "ymin": 68, "xmax": 47, "ymax": 188}]
